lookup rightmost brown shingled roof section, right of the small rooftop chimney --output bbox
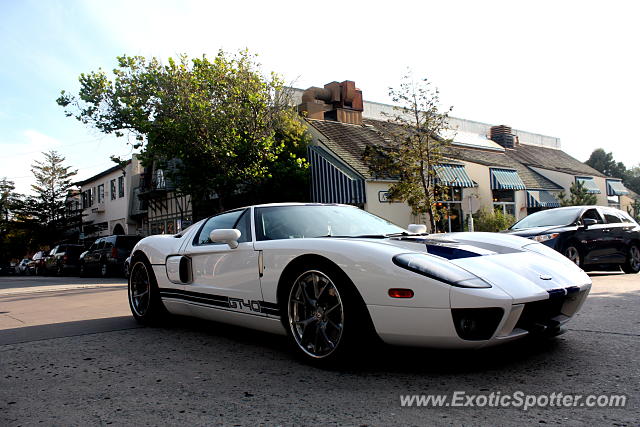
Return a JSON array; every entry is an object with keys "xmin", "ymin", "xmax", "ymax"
[{"xmin": 506, "ymin": 144, "xmax": 604, "ymax": 177}]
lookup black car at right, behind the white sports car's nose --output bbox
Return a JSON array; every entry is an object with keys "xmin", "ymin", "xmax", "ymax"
[{"xmin": 507, "ymin": 206, "xmax": 640, "ymax": 273}]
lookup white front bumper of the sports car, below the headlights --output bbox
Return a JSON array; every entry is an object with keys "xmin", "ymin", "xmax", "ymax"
[{"xmin": 367, "ymin": 284, "xmax": 591, "ymax": 348}]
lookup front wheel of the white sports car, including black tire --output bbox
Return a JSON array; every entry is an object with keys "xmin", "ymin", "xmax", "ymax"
[{"xmin": 281, "ymin": 265, "xmax": 371, "ymax": 367}]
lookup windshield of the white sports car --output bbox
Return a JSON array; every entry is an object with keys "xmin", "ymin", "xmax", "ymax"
[{"xmin": 255, "ymin": 205, "xmax": 406, "ymax": 240}]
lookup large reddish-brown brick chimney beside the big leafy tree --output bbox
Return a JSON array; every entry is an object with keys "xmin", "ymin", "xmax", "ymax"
[{"xmin": 298, "ymin": 80, "xmax": 363, "ymax": 125}]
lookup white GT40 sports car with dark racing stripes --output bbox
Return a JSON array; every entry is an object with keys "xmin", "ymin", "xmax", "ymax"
[{"xmin": 129, "ymin": 203, "xmax": 591, "ymax": 363}]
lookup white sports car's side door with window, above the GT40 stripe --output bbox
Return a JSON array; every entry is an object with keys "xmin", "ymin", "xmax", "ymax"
[{"xmin": 183, "ymin": 208, "xmax": 262, "ymax": 315}]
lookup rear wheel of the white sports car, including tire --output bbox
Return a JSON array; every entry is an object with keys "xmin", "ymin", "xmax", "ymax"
[{"xmin": 127, "ymin": 260, "xmax": 167, "ymax": 325}]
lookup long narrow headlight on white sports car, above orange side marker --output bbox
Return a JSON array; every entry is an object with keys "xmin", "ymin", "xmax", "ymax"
[{"xmin": 393, "ymin": 254, "xmax": 491, "ymax": 288}]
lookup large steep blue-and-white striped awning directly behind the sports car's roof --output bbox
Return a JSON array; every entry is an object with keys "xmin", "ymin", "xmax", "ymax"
[{"xmin": 309, "ymin": 146, "xmax": 365, "ymax": 204}]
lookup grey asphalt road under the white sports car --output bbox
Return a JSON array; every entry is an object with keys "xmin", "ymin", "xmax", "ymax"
[{"xmin": 0, "ymin": 274, "xmax": 640, "ymax": 426}]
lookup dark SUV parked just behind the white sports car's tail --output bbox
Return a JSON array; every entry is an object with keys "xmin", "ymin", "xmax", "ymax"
[{"xmin": 80, "ymin": 236, "xmax": 142, "ymax": 277}]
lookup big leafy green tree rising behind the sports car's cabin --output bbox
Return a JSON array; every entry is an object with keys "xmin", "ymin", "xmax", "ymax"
[{"xmin": 57, "ymin": 51, "xmax": 306, "ymax": 216}]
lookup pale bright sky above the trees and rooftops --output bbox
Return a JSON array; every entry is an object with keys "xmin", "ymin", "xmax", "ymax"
[{"xmin": 0, "ymin": 0, "xmax": 640, "ymax": 192}]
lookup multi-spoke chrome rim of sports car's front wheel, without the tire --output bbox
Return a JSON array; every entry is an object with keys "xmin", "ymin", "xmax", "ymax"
[{"xmin": 288, "ymin": 270, "xmax": 344, "ymax": 359}]
